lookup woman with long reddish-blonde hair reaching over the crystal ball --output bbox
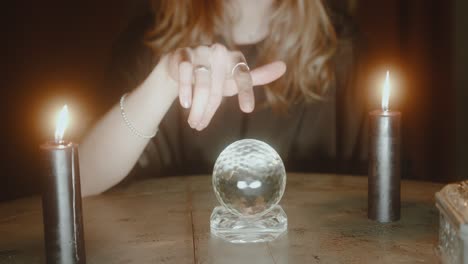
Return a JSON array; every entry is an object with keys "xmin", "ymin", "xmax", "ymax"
[{"xmin": 80, "ymin": 0, "xmax": 362, "ymax": 195}]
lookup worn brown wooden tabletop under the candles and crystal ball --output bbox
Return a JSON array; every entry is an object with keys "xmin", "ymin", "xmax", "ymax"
[{"xmin": 0, "ymin": 173, "xmax": 442, "ymax": 264}]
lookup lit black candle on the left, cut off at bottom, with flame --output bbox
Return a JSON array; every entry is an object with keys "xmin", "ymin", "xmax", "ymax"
[{"xmin": 41, "ymin": 106, "xmax": 86, "ymax": 264}]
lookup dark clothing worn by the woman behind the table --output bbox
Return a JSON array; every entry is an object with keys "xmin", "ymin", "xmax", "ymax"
[{"xmin": 108, "ymin": 9, "xmax": 366, "ymax": 182}]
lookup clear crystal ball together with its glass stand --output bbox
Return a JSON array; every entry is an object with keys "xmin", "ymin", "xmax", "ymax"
[{"xmin": 210, "ymin": 139, "xmax": 287, "ymax": 243}]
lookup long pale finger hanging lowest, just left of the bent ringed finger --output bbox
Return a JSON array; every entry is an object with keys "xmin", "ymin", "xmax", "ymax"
[{"xmin": 197, "ymin": 44, "xmax": 228, "ymax": 130}]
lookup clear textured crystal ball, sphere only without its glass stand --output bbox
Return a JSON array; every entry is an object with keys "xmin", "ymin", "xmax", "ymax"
[{"xmin": 212, "ymin": 139, "xmax": 286, "ymax": 217}]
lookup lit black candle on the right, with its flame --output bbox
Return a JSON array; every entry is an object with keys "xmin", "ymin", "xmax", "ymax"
[{"xmin": 367, "ymin": 72, "xmax": 401, "ymax": 223}]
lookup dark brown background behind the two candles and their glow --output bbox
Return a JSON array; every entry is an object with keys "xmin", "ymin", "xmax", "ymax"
[{"xmin": 0, "ymin": 0, "xmax": 468, "ymax": 201}]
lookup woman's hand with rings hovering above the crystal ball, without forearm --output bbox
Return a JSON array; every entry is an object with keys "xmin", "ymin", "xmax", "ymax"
[{"xmin": 162, "ymin": 44, "xmax": 286, "ymax": 130}]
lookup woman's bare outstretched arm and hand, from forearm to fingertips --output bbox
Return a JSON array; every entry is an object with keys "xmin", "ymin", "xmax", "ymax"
[{"xmin": 80, "ymin": 44, "xmax": 286, "ymax": 196}]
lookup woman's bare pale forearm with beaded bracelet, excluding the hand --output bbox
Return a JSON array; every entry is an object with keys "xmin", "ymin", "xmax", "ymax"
[{"xmin": 80, "ymin": 58, "xmax": 177, "ymax": 196}]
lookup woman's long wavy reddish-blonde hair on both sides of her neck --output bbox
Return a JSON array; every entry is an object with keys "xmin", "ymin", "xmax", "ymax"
[{"xmin": 146, "ymin": 0, "xmax": 337, "ymax": 106}]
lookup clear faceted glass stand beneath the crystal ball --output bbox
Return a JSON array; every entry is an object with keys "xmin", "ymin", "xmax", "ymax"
[{"xmin": 210, "ymin": 205, "xmax": 288, "ymax": 243}]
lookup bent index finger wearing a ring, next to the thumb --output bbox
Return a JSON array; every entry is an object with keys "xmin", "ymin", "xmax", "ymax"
[{"xmin": 232, "ymin": 52, "xmax": 255, "ymax": 113}]
